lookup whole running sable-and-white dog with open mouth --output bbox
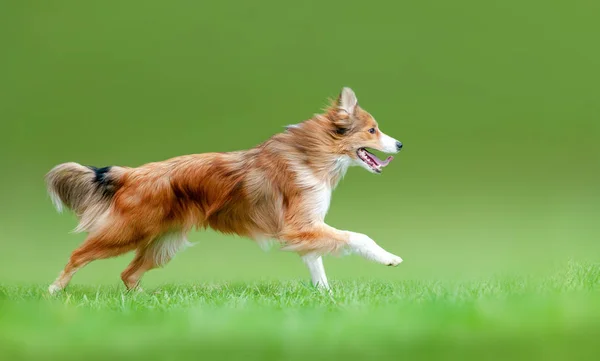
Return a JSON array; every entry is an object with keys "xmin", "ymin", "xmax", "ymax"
[{"xmin": 46, "ymin": 88, "xmax": 402, "ymax": 293}]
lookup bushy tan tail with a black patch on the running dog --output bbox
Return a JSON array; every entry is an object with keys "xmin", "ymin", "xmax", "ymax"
[{"xmin": 46, "ymin": 163, "xmax": 127, "ymax": 232}]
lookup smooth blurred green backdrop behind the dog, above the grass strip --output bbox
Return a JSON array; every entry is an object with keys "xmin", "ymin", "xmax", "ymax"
[{"xmin": 0, "ymin": 0, "xmax": 600, "ymax": 285}]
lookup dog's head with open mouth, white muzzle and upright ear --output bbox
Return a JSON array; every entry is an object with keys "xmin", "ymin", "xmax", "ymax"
[{"xmin": 327, "ymin": 88, "xmax": 402, "ymax": 173}]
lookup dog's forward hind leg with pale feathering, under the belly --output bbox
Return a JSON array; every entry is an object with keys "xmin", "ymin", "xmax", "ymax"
[{"xmin": 121, "ymin": 232, "xmax": 190, "ymax": 290}]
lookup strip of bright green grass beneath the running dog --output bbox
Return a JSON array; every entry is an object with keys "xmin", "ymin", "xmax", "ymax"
[{"xmin": 0, "ymin": 262, "xmax": 600, "ymax": 360}]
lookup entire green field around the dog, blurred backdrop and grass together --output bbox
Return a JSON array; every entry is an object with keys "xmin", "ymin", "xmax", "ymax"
[{"xmin": 0, "ymin": 0, "xmax": 600, "ymax": 360}]
